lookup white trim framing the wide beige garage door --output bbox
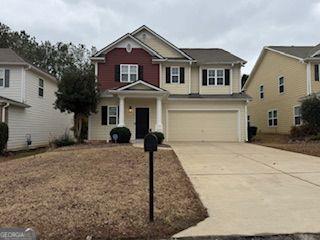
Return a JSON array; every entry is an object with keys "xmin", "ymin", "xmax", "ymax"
[{"xmin": 166, "ymin": 108, "xmax": 241, "ymax": 142}]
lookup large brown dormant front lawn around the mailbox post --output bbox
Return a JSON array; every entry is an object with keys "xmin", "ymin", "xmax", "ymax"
[{"xmin": 0, "ymin": 145, "xmax": 207, "ymax": 240}]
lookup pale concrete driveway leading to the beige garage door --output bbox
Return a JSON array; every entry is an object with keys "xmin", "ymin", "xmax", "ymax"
[{"xmin": 170, "ymin": 142, "xmax": 320, "ymax": 237}]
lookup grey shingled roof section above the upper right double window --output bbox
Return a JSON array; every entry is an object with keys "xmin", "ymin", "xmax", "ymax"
[{"xmin": 181, "ymin": 48, "xmax": 246, "ymax": 64}]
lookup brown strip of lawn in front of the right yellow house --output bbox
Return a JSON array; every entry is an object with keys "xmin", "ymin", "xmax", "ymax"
[{"xmin": 253, "ymin": 134, "xmax": 320, "ymax": 157}]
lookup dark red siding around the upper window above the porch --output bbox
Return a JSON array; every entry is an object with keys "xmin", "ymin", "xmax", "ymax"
[{"xmin": 98, "ymin": 48, "xmax": 159, "ymax": 90}]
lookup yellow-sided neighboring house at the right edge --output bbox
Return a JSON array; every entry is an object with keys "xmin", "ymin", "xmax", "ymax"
[{"xmin": 244, "ymin": 44, "xmax": 320, "ymax": 134}]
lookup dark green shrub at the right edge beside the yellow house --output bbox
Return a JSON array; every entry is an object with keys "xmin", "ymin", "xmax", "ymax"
[{"xmin": 301, "ymin": 96, "xmax": 320, "ymax": 133}]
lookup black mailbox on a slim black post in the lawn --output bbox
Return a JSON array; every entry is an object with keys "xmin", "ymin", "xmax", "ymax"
[{"xmin": 144, "ymin": 133, "xmax": 158, "ymax": 222}]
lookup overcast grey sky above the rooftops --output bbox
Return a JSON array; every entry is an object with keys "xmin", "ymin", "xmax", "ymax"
[{"xmin": 0, "ymin": 0, "xmax": 320, "ymax": 73}]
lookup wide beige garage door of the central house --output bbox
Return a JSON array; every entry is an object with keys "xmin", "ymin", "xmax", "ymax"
[{"xmin": 168, "ymin": 110, "xmax": 239, "ymax": 142}]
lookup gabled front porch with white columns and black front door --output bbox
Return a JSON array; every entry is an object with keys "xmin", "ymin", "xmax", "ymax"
[{"xmin": 89, "ymin": 81, "xmax": 168, "ymax": 140}]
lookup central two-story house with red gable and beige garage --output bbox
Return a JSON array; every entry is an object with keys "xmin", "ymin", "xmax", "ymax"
[{"xmin": 88, "ymin": 26, "xmax": 249, "ymax": 142}]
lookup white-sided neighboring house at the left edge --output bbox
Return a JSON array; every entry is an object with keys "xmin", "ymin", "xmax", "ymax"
[{"xmin": 0, "ymin": 48, "xmax": 72, "ymax": 150}]
